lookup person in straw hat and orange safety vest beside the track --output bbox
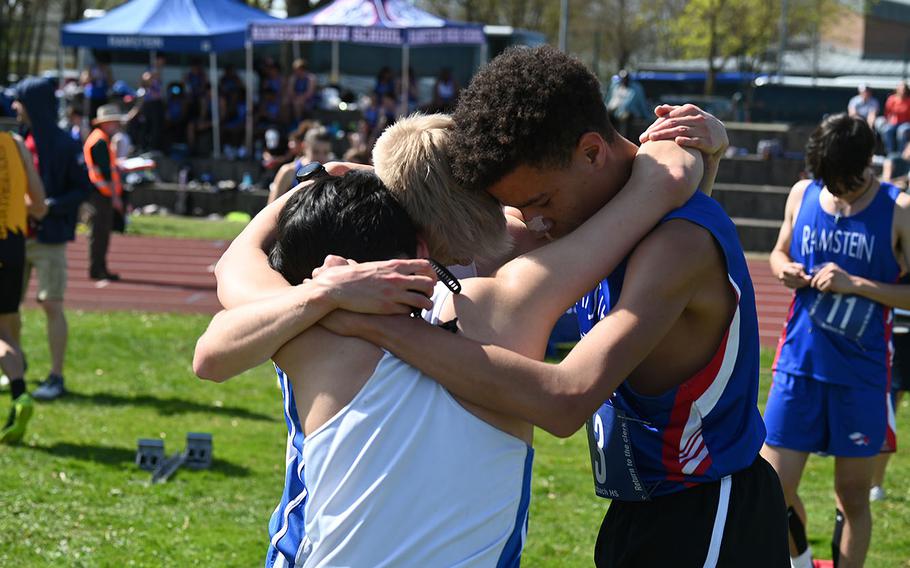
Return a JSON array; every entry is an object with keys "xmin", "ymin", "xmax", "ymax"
[{"xmin": 82, "ymin": 105, "xmax": 123, "ymax": 280}]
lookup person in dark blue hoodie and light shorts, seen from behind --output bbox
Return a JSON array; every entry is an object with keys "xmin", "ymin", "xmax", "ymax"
[{"xmin": 12, "ymin": 77, "xmax": 92, "ymax": 400}]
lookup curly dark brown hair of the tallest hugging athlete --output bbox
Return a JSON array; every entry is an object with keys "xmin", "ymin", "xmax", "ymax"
[{"xmin": 450, "ymin": 46, "xmax": 616, "ymax": 191}]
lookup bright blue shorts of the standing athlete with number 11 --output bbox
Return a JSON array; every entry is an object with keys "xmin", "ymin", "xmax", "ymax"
[{"xmin": 765, "ymin": 372, "xmax": 896, "ymax": 458}]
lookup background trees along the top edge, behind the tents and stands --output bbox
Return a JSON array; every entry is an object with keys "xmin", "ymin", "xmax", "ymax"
[{"xmin": 0, "ymin": 0, "xmax": 848, "ymax": 94}]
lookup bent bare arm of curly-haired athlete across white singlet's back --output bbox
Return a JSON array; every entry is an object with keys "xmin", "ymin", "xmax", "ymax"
[{"xmin": 323, "ymin": 220, "xmax": 716, "ymax": 437}]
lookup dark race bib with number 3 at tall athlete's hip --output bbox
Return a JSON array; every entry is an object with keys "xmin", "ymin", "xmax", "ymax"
[{"xmin": 586, "ymin": 404, "xmax": 650, "ymax": 501}]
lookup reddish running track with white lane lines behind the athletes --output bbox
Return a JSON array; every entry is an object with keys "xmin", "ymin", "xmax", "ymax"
[{"xmin": 19, "ymin": 234, "xmax": 791, "ymax": 347}]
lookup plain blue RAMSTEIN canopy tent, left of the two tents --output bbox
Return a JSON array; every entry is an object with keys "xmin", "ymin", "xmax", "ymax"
[{"xmin": 60, "ymin": 0, "xmax": 275, "ymax": 158}]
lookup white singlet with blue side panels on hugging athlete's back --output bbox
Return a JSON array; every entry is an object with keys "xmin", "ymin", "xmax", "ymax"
[{"xmin": 266, "ymin": 284, "xmax": 533, "ymax": 567}]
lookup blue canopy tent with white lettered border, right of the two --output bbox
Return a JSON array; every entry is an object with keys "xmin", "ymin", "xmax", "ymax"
[{"xmin": 250, "ymin": 0, "xmax": 486, "ymax": 115}]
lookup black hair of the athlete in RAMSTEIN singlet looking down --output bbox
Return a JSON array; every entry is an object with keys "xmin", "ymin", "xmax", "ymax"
[{"xmin": 806, "ymin": 113, "xmax": 875, "ymax": 194}]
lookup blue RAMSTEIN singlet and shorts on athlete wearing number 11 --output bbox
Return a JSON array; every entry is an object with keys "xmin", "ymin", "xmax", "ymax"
[{"xmin": 773, "ymin": 180, "xmax": 900, "ymax": 389}]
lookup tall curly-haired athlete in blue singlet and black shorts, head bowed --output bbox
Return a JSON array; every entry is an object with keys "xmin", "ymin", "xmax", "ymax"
[{"xmin": 212, "ymin": 47, "xmax": 787, "ymax": 567}]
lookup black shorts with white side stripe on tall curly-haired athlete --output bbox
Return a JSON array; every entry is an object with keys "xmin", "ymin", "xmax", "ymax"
[{"xmin": 594, "ymin": 456, "xmax": 790, "ymax": 568}]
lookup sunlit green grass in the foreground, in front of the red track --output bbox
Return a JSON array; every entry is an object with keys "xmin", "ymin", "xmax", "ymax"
[{"xmin": 0, "ymin": 310, "xmax": 910, "ymax": 568}]
